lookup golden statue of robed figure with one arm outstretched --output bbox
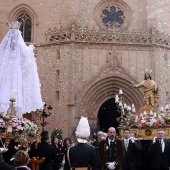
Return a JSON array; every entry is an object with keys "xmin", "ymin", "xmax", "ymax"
[{"xmin": 134, "ymin": 72, "xmax": 159, "ymax": 106}]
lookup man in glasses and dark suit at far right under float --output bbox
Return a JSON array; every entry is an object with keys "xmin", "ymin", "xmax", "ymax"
[{"xmin": 148, "ymin": 129, "xmax": 170, "ymax": 170}]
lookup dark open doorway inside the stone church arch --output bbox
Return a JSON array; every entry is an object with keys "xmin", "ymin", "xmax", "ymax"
[{"xmin": 98, "ymin": 98, "xmax": 120, "ymax": 132}]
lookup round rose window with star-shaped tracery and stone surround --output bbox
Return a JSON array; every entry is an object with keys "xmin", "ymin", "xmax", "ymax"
[{"xmin": 95, "ymin": 0, "xmax": 131, "ymax": 31}]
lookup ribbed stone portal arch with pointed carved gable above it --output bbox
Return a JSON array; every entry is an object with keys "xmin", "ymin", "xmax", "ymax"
[{"xmin": 76, "ymin": 47, "xmax": 143, "ymax": 124}]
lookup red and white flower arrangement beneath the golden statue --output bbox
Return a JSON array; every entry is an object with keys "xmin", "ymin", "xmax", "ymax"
[{"xmin": 131, "ymin": 111, "xmax": 168, "ymax": 128}]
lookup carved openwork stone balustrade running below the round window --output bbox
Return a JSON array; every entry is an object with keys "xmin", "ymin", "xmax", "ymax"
[{"xmin": 44, "ymin": 21, "xmax": 170, "ymax": 49}]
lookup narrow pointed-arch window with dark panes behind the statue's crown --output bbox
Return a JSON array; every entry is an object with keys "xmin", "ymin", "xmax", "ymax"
[{"xmin": 17, "ymin": 12, "xmax": 32, "ymax": 42}]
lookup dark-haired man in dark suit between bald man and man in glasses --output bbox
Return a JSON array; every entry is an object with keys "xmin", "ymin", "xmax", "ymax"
[{"xmin": 122, "ymin": 129, "xmax": 141, "ymax": 170}]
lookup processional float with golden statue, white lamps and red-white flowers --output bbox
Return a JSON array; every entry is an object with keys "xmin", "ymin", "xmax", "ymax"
[{"xmin": 115, "ymin": 71, "xmax": 170, "ymax": 140}]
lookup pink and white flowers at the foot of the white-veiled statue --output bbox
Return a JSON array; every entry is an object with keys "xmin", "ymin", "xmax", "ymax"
[{"xmin": 0, "ymin": 113, "xmax": 38, "ymax": 139}]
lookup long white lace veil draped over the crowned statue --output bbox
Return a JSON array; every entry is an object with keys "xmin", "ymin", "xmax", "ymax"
[{"xmin": 0, "ymin": 29, "xmax": 42, "ymax": 116}]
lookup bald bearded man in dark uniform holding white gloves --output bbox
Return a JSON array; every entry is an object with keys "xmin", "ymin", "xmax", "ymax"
[{"xmin": 98, "ymin": 127, "xmax": 124, "ymax": 170}]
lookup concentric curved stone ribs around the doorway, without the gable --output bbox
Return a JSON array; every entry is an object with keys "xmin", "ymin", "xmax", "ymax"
[{"xmin": 78, "ymin": 75, "xmax": 143, "ymax": 119}]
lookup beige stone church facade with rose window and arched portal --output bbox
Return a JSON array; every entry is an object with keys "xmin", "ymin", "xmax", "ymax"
[{"xmin": 0, "ymin": 0, "xmax": 170, "ymax": 136}]
